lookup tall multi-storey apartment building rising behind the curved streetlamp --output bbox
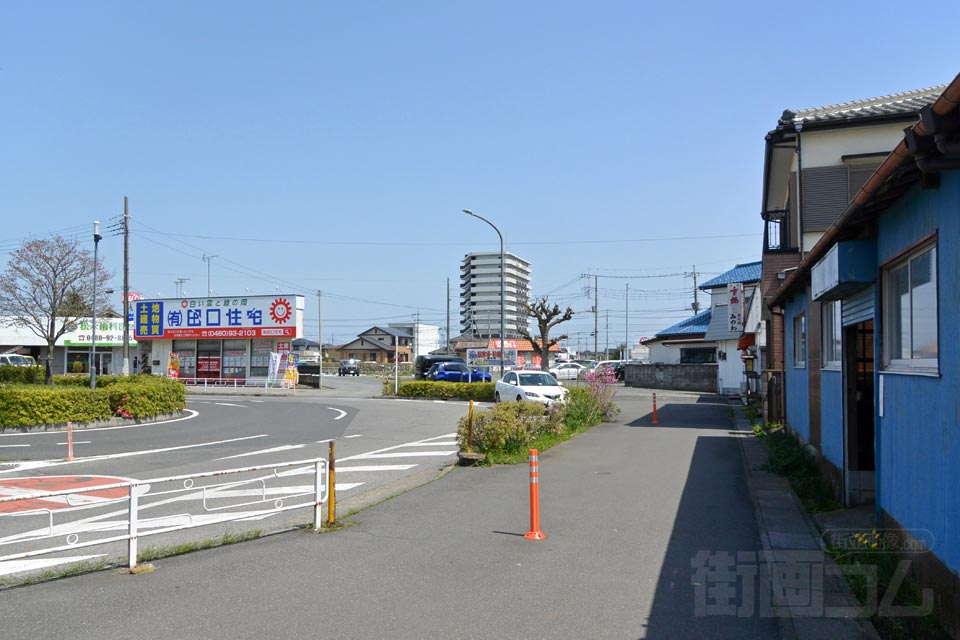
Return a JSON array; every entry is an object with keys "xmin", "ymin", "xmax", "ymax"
[{"xmin": 460, "ymin": 251, "xmax": 530, "ymax": 338}]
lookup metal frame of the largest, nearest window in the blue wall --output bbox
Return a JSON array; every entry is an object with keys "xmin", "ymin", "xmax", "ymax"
[{"xmin": 880, "ymin": 234, "xmax": 940, "ymax": 375}]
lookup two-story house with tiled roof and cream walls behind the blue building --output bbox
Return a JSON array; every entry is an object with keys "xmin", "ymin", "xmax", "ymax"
[{"xmin": 757, "ymin": 85, "xmax": 944, "ymax": 424}]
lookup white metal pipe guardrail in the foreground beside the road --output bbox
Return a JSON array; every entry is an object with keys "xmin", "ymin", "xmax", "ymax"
[{"xmin": 0, "ymin": 458, "xmax": 327, "ymax": 569}]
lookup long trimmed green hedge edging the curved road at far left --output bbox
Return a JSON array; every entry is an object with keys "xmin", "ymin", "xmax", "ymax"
[{"xmin": 0, "ymin": 375, "xmax": 186, "ymax": 428}]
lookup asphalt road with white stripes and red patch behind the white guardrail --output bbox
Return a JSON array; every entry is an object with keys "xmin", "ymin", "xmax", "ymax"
[{"xmin": 0, "ymin": 377, "xmax": 476, "ymax": 576}]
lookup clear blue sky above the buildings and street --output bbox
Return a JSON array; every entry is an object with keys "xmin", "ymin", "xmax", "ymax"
[{"xmin": 0, "ymin": 1, "xmax": 960, "ymax": 347}]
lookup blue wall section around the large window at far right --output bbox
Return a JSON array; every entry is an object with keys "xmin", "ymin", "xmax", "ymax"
[{"xmin": 875, "ymin": 171, "xmax": 960, "ymax": 571}]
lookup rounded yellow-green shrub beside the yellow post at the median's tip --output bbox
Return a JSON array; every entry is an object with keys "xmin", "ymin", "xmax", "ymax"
[{"xmin": 457, "ymin": 402, "xmax": 564, "ymax": 453}]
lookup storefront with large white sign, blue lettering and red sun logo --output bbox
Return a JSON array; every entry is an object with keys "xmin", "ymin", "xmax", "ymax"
[{"xmin": 134, "ymin": 295, "xmax": 304, "ymax": 382}]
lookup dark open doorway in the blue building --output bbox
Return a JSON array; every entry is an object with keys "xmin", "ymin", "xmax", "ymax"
[{"xmin": 843, "ymin": 320, "xmax": 876, "ymax": 506}]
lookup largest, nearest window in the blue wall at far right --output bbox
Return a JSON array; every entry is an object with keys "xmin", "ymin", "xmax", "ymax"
[{"xmin": 883, "ymin": 243, "xmax": 939, "ymax": 373}]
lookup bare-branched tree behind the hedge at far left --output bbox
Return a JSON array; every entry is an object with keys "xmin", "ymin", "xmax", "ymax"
[{"xmin": 0, "ymin": 236, "xmax": 112, "ymax": 384}]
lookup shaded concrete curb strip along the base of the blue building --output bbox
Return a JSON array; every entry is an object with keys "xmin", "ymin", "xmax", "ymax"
[{"xmin": 733, "ymin": 405, "xmax": 880, "ymax": 640}]
